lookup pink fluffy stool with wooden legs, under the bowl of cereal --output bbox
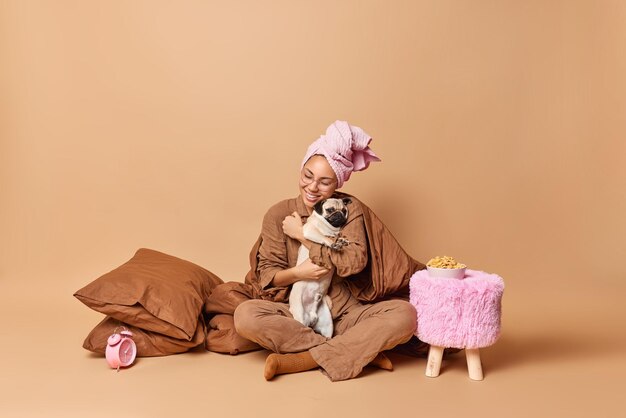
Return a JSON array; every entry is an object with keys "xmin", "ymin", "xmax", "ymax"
[{"xmin": 410, "ymin": 269, "xmax": 504, "ymax": 380}]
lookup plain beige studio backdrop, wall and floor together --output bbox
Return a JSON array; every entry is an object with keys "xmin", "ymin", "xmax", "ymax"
[{"xmin": 0, "ymin": 0, "xmax": 626, "ymax": 417}]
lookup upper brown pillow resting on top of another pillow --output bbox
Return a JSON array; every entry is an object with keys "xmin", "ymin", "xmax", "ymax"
[{"xmin": 74, "ymin": 248, "xmax": 223, "ymax": 341}]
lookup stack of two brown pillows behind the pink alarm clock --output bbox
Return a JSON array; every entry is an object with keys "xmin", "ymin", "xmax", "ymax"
[{"xmin": 74, "ymin": 248, "xmax": 223, "ymax": 356}]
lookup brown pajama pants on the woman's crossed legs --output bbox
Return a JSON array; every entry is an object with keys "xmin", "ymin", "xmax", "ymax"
[{"xmin": 235, "ymin": 300, "xmax": 417, "ymax": 381}]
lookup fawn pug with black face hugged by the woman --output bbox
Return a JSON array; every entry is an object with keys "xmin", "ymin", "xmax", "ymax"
[{"xmin": 289, "ymin": 197, "xmax": 352, "ymax": 338}]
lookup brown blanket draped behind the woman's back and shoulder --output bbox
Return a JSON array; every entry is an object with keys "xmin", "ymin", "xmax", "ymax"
[{"xmin": 204, "ymin": 196, "xmax": 426, "ymax": 354}]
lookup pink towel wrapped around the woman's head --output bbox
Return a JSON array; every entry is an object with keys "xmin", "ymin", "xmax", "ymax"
[{"xmin": 302, "ymin": 120, "xmax": 380, "ymax": 188}]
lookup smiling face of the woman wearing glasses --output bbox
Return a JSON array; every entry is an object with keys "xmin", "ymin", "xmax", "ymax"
[{"xmin": 300, "ymin": 155, "xmax": 337, "ymax": 212}]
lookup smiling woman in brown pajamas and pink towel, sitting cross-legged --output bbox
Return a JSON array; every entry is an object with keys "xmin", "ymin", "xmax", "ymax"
[{"xmin": 234, "ymin": 121, "xmax": 423, "ymax": 381}]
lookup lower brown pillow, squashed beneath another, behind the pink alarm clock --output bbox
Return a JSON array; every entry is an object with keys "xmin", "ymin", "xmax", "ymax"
[{"xmin": 83, "ymin": 316, "xmax": 206, "ymax": 357}]
